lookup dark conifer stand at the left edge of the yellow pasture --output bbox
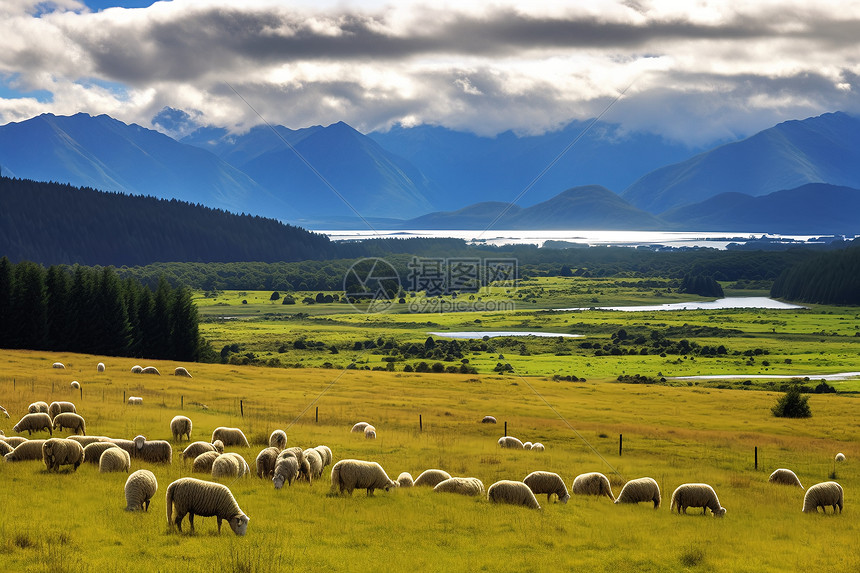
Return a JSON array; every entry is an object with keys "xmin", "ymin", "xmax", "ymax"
[{"xmin": 0, "ymin": 257, "xmax": 207, "ymax": 361}]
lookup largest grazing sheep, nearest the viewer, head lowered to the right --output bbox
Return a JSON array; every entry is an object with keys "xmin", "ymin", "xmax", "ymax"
[{"xmin": 165, "ymin": 477, "xmax": 250, "ymax": 535}]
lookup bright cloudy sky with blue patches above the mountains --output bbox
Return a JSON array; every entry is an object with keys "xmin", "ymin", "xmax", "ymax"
[{"xmin": 0, "ymin": 0, "xmax": 860, "ymax": 144}]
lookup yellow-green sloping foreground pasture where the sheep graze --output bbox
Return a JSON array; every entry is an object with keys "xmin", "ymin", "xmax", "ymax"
[{"xmin": 0, "ymin": 348, "xmax": 860, "ymax": 573}]
